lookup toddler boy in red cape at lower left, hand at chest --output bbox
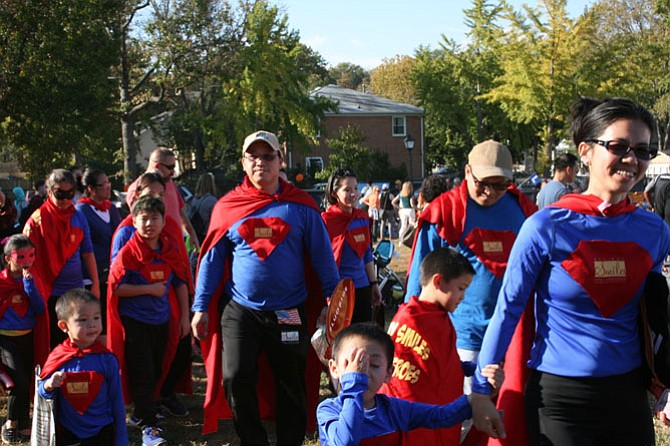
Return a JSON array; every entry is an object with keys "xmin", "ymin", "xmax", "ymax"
[{"xmin": 38, "ymin": 288, "xmax": 128, "ymax": 446}]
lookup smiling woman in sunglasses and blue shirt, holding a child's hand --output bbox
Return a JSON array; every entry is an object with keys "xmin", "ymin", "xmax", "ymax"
[{"xmin": 473, "ymin": 98, "xmax": 670, "ymax": 445}]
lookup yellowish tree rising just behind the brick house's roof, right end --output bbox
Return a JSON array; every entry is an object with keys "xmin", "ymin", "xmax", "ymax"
[{"xmin": 370, "ymin": 56, "xmax": 416, "ymax": 104}]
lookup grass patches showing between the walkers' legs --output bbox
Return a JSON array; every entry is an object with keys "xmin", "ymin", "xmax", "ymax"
[{"xmin": 5, "ymin": 247, "xmax": 670, "ymax": 446}]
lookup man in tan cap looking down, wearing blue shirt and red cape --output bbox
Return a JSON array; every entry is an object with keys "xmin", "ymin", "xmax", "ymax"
[{"xmin": 405, "ymin": 140, "xmax": 537, "ymax": 440}]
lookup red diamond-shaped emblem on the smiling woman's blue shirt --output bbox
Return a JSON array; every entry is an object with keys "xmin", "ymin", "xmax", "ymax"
[{"xmin": 561, "ymin": 240, "xmax": 653, "ymax": 317}]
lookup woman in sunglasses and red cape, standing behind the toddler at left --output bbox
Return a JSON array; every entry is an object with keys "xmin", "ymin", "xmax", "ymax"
[{"xmin": 23, "ymin": 169, "xmax": 100, "ymax": 348}]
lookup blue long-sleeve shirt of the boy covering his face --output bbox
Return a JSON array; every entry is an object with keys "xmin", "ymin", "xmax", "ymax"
[{"xmin": 316, "ymin": 373, "xmax": 472, "ymax": 446}]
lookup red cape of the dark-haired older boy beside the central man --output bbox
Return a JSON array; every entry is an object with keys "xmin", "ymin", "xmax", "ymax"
[{"xmin": 107, "ymin": 231, "xmax": 190, "ymax": 404}]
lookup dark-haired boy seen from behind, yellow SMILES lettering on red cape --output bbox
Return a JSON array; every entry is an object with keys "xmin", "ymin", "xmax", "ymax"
[{"xmin": 381, "ymin": 248, "xmax": 502, "ymax": 446}]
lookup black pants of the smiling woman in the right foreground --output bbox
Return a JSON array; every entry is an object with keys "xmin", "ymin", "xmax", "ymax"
[{"xmin": 526, "ymin": 369, "xmax": 654, "ymax": 446}]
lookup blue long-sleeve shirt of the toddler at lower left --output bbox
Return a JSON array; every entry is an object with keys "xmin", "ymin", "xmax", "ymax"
[{"xmin": 38, "ymin": 353, "xmax": 128, "ymax": 446}]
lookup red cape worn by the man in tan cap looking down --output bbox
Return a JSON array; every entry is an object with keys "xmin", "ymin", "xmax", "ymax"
[{"xmin": 407, "ymin": 180, "xmax": 537, "ymax": 446}]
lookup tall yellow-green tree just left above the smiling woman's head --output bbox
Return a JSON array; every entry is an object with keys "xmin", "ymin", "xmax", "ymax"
[{"xmin": 482, "ymin": 0, "xmax": 592, "ymax": 156}]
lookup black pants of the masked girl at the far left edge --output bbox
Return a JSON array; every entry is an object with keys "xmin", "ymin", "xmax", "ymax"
[{"xmin": 0, "ymin": 332, "xmax": 34, "ymax": 430}]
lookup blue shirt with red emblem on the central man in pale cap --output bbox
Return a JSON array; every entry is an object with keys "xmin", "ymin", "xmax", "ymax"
[{"xmin": 192, "ymin": 202, "xmax": 340, "ymax": 312}]
